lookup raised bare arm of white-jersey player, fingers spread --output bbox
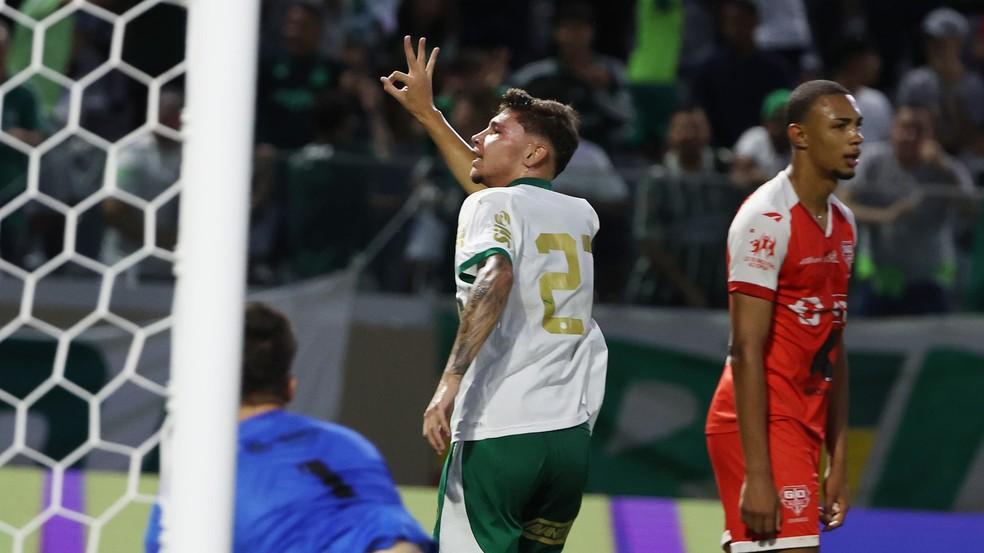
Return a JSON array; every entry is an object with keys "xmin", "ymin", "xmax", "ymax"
[{"xmin": 379, "ymin": 35, "xmax": 485, "ymax": 194}]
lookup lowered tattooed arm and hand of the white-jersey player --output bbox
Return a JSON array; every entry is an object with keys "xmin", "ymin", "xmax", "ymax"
[{"xmin": 423, "ymin": 254, "xmax": 513, "ymax": 454}]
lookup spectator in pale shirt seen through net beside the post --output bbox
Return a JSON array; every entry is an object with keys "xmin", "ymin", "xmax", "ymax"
[{"xmin": 100, "ymin": 88, "xmax": 184, "ymax": 279}]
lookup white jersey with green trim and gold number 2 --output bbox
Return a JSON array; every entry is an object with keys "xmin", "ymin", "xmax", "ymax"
[{"xmin": 451, "ymin": 179, "xmax": 608, "ymax": 441}]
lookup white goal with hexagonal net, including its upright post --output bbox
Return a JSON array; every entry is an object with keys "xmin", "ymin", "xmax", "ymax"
[{"xmin": 0, "ymin": 0, "xmax": 257, "ymax": 553}]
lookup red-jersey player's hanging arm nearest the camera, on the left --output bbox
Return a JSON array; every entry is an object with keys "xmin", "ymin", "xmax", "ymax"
[{"xmin": 731, "ymin": 292, "xmax": 781, "ymax": 535}]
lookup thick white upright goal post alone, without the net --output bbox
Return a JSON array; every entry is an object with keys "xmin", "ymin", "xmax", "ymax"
[{"xmin": 169, "ymin": 0, "xmax": 259, "ymax": 553}]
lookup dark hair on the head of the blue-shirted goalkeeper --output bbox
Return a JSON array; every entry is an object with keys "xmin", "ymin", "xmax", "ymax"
[{"xmin": 240, "ymin": 303, "xmax": 297, "ymax": 405}]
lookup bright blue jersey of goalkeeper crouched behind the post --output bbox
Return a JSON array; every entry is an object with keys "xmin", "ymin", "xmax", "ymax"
[{"xmin": 145, "ymin": 410, "xmax": 437, "ymax": 553}]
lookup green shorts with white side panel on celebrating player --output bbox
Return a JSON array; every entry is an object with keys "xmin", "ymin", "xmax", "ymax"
[{"xmin": 434, "ymin": 423, "xmax": 591, "ymax": 553}]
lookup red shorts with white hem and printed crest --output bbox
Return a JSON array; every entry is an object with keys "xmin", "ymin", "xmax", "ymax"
[{"xmin": 707, "ymin": 420, "xmax": 821, "ymax": 553}]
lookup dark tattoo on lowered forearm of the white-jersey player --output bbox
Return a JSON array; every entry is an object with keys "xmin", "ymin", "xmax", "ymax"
[{"xmin": 445, "ymin": 264, "xmax": 510, "ymax": 376}]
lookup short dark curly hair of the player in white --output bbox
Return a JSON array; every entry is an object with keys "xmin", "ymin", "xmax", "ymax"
[{"xmin": 499, "ymin": 88, "xmax": 580, "ymax": 177}]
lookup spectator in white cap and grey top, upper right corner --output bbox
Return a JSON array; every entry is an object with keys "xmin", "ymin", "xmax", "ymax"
[{"xmin": 897, "ymin": 8, "xmax": 984, "ymax": 153}]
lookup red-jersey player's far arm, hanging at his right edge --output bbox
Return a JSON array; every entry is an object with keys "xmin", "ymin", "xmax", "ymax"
[{"xmin": 820, "ymin": 337, "xmax": 848, "ymax": 531}]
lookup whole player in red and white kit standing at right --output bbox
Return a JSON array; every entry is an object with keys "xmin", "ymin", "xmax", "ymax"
[{"xmin": 706, "ymin": 81, "xmax": 864, "ymax": 553}]
